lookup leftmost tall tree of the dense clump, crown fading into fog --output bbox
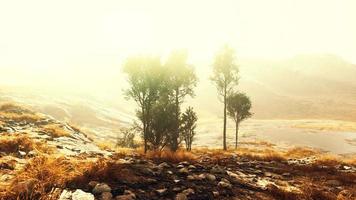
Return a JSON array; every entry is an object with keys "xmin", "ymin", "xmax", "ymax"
[{"xmin": 123, "ymin": 56, "xmax": 164, "ymax": 153}]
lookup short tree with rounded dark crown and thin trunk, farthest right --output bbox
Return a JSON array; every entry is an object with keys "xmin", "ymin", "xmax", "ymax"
[{"xmin": 227, "ymin": 93, "xmax": 252, "ymax": 149}]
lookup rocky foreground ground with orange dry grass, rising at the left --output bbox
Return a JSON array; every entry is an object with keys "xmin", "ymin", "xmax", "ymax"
[{"xmin": 0, "ymin": 106, "xmax": 356, "ymax": 200}]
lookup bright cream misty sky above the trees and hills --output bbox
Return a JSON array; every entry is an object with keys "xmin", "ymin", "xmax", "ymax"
[{"xmin": 0, "ymin": 0, "xmax": 356, "ymax": 89}]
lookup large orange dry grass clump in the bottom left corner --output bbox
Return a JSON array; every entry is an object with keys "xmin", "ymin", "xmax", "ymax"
[{"xmin": 0, "ymin": 157, "xmax": 85, "ymax": 200}]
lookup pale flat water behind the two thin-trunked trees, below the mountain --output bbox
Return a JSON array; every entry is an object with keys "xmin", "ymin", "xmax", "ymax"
[{"xmin": 195, "ymin": 120, "xmax": 356, "ymax": 154}]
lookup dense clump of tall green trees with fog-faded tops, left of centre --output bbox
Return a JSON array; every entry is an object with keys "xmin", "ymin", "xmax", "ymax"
[{"xmin": 123, "ymin": 51, "xmax": 197, "ymax": 152}]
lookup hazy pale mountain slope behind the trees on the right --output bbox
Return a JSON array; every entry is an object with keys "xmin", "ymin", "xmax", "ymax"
[{"xmin": 196, "ymin": 55, "xmax": 356, "ymax": 121}]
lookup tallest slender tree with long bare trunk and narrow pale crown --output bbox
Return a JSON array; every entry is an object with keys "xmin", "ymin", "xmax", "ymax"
[{"xmin": 211, "ymin": 46, "xmax": 239, "ymax": 150}]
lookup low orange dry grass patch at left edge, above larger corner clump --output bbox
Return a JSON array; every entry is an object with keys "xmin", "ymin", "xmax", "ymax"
[{"xmin": 0, "ymin": 133, "xmax": 53, "ymax": 154}]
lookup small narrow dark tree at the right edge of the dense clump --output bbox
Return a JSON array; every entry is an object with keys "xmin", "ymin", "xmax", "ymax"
[{"xmin": 181, "ymin": 107, "xmax": 198, "ymax": 151}]
